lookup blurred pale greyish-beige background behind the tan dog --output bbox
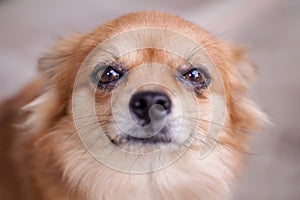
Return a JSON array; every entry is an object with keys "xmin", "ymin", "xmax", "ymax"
[{"xmin": 0, "ymin": 0, "xmax": 300, "ymax": 200}]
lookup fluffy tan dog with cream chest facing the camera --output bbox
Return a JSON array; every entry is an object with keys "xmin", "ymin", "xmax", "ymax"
[{"xmin": 0, "ymin": 11, "xmax": 266, "ymax": 200}]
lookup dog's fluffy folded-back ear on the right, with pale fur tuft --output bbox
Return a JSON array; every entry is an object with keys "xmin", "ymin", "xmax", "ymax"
[{"xmin": 226, "ymin": 44, "xmax": 270, "ymax": 131}]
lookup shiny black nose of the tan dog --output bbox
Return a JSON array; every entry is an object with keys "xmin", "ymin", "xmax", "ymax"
[{"xmin": 129, "ymin": 91, "xmax": 172, "ymax": 124}]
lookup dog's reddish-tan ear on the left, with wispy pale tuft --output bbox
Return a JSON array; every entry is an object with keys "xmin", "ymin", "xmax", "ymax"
[{"xmin": 23, "ymin": 36, "xmax": 85, "ymax": 131}]
